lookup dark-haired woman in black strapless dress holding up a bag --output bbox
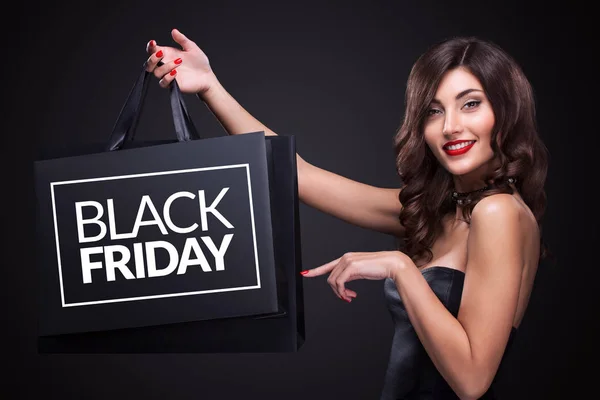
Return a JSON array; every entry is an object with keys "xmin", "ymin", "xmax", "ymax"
[{"xmin": 147, "ymin": 29, "xmax": 548, "ymax": 399}]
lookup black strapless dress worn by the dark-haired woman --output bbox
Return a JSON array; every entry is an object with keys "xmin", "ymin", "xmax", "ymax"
[{"xmin": 380, "ymin": 266, "xmax": 516, "ymax": 400}]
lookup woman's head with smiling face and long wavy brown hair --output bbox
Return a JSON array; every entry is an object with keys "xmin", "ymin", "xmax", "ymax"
[{"xmin": 395, "ymin": 38, "xmax": 548, "ymax": 264}]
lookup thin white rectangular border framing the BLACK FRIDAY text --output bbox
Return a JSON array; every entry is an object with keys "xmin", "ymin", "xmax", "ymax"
[{"xmin": 50, "ymin": 164, "xmax": 261, "ymax": 307}]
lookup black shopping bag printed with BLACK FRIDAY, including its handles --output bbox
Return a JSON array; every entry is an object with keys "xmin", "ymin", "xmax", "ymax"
[{"xmin": 35, "ymin": 63, "xmax": 304, "ymax": 353}]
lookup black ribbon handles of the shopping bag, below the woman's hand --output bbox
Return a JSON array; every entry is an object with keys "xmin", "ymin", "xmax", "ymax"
[{"xmin": 105, "ymin": 64, "xmax": 200, "ymax": 151}]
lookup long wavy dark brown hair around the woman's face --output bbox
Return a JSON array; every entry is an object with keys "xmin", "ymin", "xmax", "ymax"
[{"xmin": 394, "ymin": 37, "xmax": 549, "ymax": 262}]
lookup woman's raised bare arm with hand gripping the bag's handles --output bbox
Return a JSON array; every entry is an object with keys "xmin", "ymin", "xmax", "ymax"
[{"xmin": 147, "ymin": 29, "xmax": 404, "ymax": 236}]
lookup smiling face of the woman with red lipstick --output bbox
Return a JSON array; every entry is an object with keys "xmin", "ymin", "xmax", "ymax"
[{"xmin": 423, "ymin": 67, "xmax": 494, "ymax": 177}]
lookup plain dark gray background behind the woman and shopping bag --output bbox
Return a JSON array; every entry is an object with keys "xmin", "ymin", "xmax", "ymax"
[{"xmin": 5, "ymin": 0, "xmax": 598, "ymax": 400}]
